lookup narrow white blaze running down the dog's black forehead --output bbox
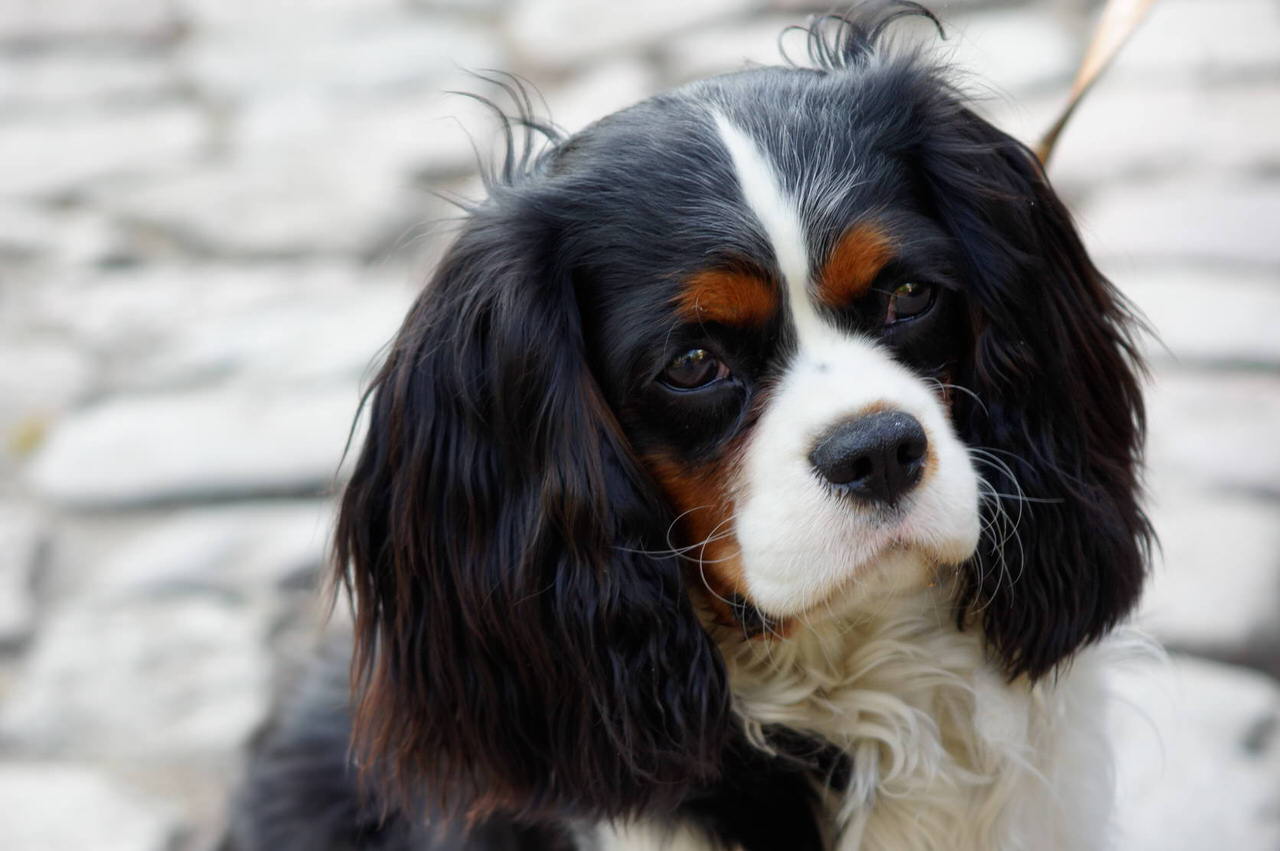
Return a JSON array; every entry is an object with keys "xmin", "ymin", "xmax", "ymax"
[{"xmin": 716, "ymin": 114, "xmax": 818, "ymax": 338}]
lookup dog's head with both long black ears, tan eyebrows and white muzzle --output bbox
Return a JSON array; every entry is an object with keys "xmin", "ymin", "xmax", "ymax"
[{"xmin": 337, "ymin": 4, "xmax": 1148, "ymax": 815}]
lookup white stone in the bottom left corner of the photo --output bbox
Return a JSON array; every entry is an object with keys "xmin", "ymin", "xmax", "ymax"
[{"xmin": 0, "ymin": 761, "xmax": 179, "ymax": 851}]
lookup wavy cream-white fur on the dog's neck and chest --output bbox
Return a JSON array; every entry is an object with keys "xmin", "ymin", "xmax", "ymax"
[{"xmin": 713, "ymin": 586, "xmax": 1110, "ymax": 850}]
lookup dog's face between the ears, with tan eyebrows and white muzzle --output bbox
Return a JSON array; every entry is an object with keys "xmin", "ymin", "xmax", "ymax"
[{"xmin": 576, "ymin": 87, "xmax": 979, "ymax": 624}]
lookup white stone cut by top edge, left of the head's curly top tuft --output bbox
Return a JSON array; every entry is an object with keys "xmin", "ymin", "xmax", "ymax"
[{"xmin": 504, "ymin": 0, "xmax": 741, "ymax": 69}]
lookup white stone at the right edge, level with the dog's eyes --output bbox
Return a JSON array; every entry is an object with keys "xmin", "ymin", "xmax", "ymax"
[{"xmin": 1107, "ymin": 262, "xmax": 1280, "ymax": 365}]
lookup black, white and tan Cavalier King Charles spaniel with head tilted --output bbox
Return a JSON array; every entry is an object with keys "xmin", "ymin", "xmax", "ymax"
[{"xmin": 237, "ymin": 3, "xmax": 1151, "ymax": 851}]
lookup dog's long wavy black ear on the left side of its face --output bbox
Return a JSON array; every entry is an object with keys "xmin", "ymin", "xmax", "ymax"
[{"xmin": 335, "ymin": 187, "xmax": 730, "ymax": 819}]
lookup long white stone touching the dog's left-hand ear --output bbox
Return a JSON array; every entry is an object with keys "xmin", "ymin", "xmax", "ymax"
[{"xmin": 29, "ymin": 381, "xmax": 358, "ymax": 507}]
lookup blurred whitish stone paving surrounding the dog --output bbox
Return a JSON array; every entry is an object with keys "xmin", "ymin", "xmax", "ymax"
[{"xmin": 0, "ymin": 0, "xmax": 1280, "ymax": 851}]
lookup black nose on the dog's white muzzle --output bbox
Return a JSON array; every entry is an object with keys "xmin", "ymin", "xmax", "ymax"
[{"xmin": 809, "ymin": 411, "xmax": 929, "ymax": 504}]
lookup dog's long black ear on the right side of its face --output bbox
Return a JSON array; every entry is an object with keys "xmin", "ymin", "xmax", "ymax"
[{"xmin": 923, "ymin": 107, "xmax": 1151, "ymax": 677}]
